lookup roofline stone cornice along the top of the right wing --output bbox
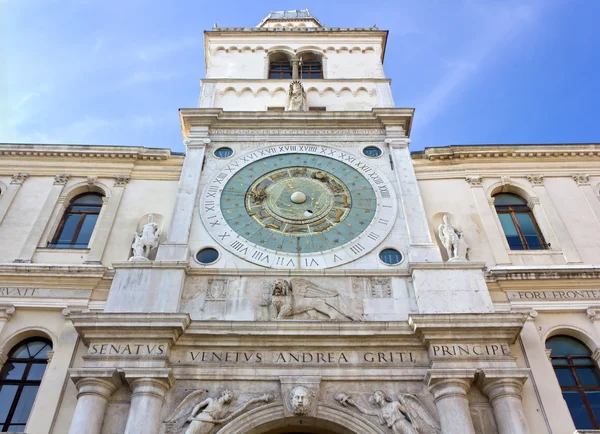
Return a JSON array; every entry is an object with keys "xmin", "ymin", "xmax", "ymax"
[{"xmin": 412, "ymin": 144, "xmax": 600, "ymax": 161}]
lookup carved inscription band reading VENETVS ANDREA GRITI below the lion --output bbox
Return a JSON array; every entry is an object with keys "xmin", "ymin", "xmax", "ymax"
[{"xmin": 182, "ymin": 349, "xmax": 426, "ymax": 365}]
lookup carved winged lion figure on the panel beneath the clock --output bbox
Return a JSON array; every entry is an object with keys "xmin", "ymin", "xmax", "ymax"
[{"xmin": 271, "ymin": 279, "xmax": 362, "ymax": 321}]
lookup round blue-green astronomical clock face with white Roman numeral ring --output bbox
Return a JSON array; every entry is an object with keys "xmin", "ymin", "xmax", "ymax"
[{"xmin": 200, "ymin": 145, "xmax": 396, "ymax": 269}]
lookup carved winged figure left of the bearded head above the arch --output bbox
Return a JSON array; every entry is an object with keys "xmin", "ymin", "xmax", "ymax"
[{"xmin": 165, "ymin": 389, "xmax": 274, "ymax": 434}]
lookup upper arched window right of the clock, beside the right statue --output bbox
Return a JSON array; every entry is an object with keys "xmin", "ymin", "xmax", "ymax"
[{"xmin": 494, "ymin": 193, "xmax": 548, "ymax": 250}]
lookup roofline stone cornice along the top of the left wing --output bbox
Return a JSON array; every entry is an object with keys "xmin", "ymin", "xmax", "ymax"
[{"xmin": 0, "ymin": 143, "xmax": 178, "ymax": 161}]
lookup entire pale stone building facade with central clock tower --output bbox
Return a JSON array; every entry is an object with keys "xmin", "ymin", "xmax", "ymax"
[{"xmin": 0, "ymin": 11, "xmax": 600, "ymax": 434}]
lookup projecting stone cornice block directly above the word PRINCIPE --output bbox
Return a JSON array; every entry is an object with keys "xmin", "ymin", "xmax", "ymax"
[{"xmin": 408, "ymin": 313, "xmax": 527, "ymax": 344}]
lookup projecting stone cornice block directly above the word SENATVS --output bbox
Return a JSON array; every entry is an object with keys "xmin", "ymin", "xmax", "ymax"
[{"xmin": 69, "ymin": 313, "xmax": 190, "ymax": 345}]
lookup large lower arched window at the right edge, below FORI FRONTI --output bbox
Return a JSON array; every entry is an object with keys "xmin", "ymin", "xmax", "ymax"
[{"xmin": 546, "ymin": 336, "xmax": 600, "ymax": 429}]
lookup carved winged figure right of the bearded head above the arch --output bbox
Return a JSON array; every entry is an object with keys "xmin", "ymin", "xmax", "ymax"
[{"xmin": 334, "ymin": 390, "xmax": 442, "ymax": 434}]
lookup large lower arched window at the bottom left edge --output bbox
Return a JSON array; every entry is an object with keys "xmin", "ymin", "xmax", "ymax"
[{"xmin": 0, "ymin": 338, "xmax": 52, "ymax": 432}]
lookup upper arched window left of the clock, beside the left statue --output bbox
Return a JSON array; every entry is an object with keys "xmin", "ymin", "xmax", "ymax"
[{"xmin": 48, "ymin": 193, "xmax": 103, "ymax": 249}]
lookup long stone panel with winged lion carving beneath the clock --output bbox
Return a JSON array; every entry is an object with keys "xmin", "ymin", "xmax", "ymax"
[{"xmin": 181, "ymin": 276, "xmax": 384, "ymax": 321}]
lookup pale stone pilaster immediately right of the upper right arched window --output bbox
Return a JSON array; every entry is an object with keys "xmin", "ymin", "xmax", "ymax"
[{"xmin": 527, "ymin": 175, "xmax": 581, "ymax": 264}]
